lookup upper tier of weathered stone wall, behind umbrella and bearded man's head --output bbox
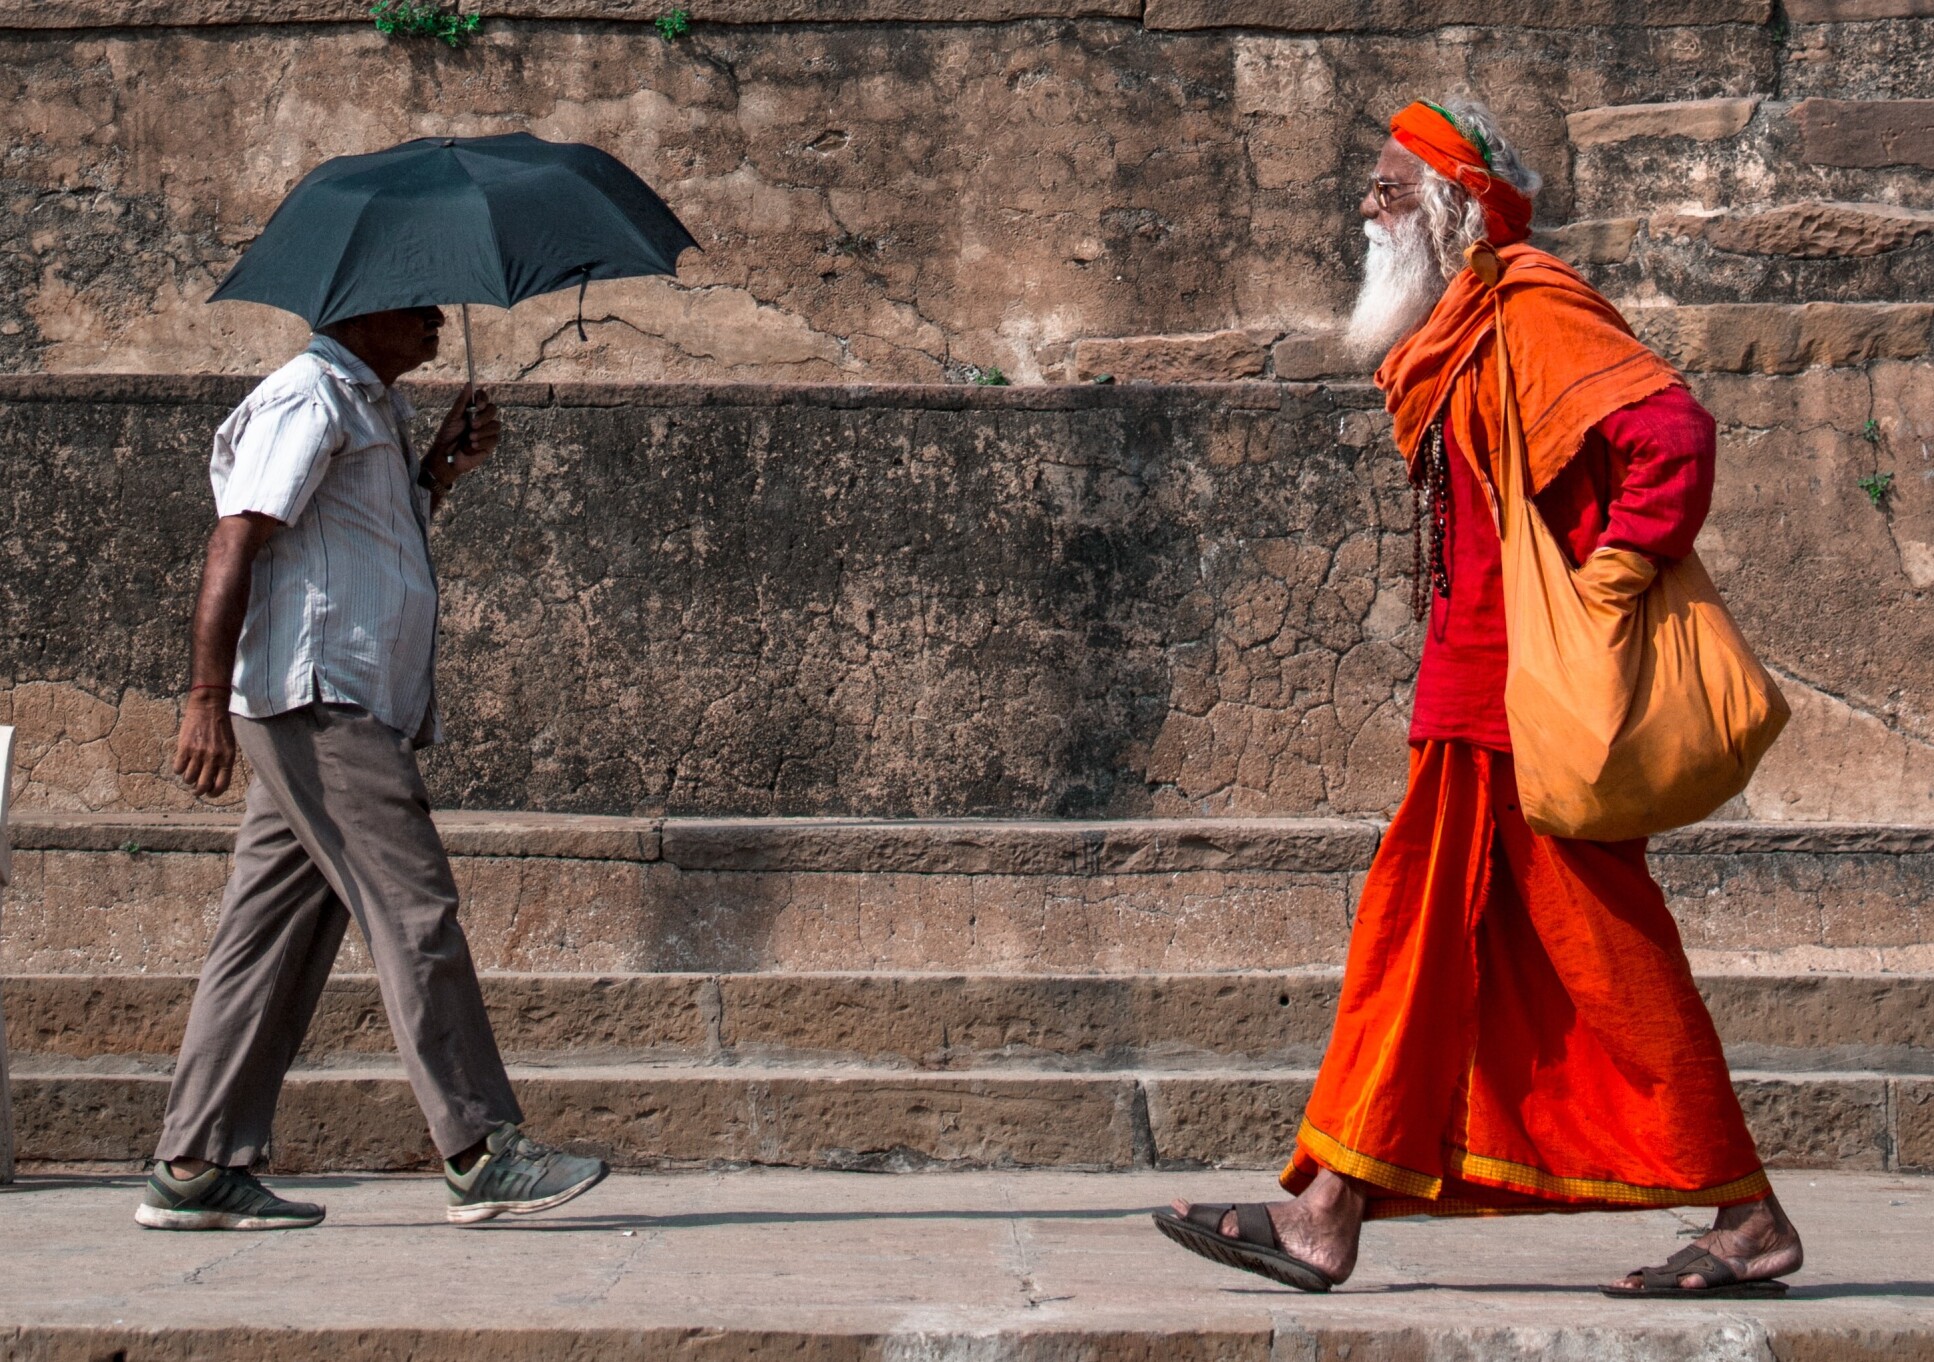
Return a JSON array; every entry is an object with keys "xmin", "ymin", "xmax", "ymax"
[{"xmin": 0, "ymin": 9, "xmax": 1934, "ymax": 383}]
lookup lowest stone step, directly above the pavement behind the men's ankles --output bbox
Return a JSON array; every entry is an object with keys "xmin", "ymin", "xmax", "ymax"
[{"xmin": 14, "ymin": 1058, "xmax": 1934, "ymax": 1172}]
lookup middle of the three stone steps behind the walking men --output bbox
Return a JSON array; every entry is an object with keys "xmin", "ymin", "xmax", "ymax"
[{"xmin": 0, "ymin": 969, "xmax": 1934, "ymax": 1074}]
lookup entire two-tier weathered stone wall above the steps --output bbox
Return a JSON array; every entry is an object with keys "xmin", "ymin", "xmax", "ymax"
[{"xmin": 0, "ymin": 0, "xmax": 1934, "ymax": 822}]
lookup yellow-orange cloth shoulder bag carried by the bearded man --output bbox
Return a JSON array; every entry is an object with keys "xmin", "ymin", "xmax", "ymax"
[{"xmin": 1489, "ymin": 279, "xmax": 1791, "ymax": 842}]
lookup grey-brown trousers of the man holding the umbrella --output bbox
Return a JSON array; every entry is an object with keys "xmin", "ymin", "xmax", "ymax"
[{"xmin": 157, "ymin": 704, "xmax": 524, "ymax": 1167}]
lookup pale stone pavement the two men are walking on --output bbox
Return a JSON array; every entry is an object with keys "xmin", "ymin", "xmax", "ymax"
[{"xmin": 0, "ymin": 1170, "xmax": 1934, "ymax": 1362}]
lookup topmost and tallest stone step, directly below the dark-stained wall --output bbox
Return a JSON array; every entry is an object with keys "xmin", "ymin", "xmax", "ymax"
[{"xmin": 11, "ymin": 813, "xmax": 1934, "ymax": 973}]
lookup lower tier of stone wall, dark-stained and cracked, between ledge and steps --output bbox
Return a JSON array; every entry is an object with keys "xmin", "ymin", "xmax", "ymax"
[{"xmin": 0, "ymin": 362, "xmax": 1934, "ymax": 822}]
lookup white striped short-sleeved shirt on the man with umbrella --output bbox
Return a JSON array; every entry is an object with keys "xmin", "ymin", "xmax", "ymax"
[{"xmin": 209, "ymin": 337, "xmax": 437, "ymax": 735}]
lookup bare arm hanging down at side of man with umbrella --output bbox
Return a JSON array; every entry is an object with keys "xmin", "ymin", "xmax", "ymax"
[{"xmin": 174, "ymin": 511, "xmax": 282, "ymax": 795}]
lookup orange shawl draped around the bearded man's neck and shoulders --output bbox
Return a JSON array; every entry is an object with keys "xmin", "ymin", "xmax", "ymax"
[{"xmin": 1377, "ymin": 244, "xmax": 1681, "ymax": 491}]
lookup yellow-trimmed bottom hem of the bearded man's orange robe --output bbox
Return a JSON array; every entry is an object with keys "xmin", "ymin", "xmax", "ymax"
[{"xmin": 1284, "ymin": 1118, "xmax": 1773, "ymax": 1219}]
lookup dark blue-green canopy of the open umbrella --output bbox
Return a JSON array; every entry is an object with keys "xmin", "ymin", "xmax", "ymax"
[{"xmin": 209, "ymin": 132, "xmax": 698, "ymax": 327}]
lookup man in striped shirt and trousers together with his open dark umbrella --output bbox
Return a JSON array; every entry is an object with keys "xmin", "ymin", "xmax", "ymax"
[{"xmin": 135, "ymin": 135, "xmax": 690, "ymax": 1230}]
